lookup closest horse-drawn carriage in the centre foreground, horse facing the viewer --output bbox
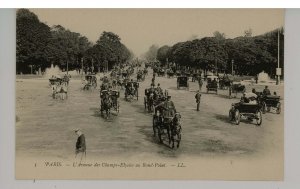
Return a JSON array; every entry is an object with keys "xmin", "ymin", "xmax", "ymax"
[{"xmin": 153, "ymin": 106, "xmax": 181, "ymax": 148}]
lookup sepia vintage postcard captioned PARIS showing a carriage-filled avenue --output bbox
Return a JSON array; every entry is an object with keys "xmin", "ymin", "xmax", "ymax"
[{"xmin": 15, "ymin": 9, "xmax": 284, "ymax": 180}]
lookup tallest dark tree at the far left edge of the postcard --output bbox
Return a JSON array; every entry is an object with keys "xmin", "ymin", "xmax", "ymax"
[{"xmin": 16, "ymin": 9, "xmax": 51, "ymax": 73}]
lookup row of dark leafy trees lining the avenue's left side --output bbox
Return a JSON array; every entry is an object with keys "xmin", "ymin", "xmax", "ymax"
[{"xmin": 16, "ymin": 9, "xmax": 132, "ymax": 73}]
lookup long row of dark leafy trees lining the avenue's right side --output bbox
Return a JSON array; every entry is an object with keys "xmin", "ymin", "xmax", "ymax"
[{"xmin": 152, "ymin": 28, "xmax": 284, "ymax": 76}]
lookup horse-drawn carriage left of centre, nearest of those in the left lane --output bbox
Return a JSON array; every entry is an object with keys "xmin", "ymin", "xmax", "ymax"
[{"xmin": 100, "ymin": 90, "xmax": 120, "ymax": 119}]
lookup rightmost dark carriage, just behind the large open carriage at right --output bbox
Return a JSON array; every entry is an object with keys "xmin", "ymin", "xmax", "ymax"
[{"xmin": 259, "ymin": 94, "xmax": 281, "ymax": 114}]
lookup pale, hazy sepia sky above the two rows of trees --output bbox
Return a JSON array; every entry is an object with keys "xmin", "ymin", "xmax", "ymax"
[{"xmin": 30, "ymin": 9, "xmax": 284, "ymax": 56}]
